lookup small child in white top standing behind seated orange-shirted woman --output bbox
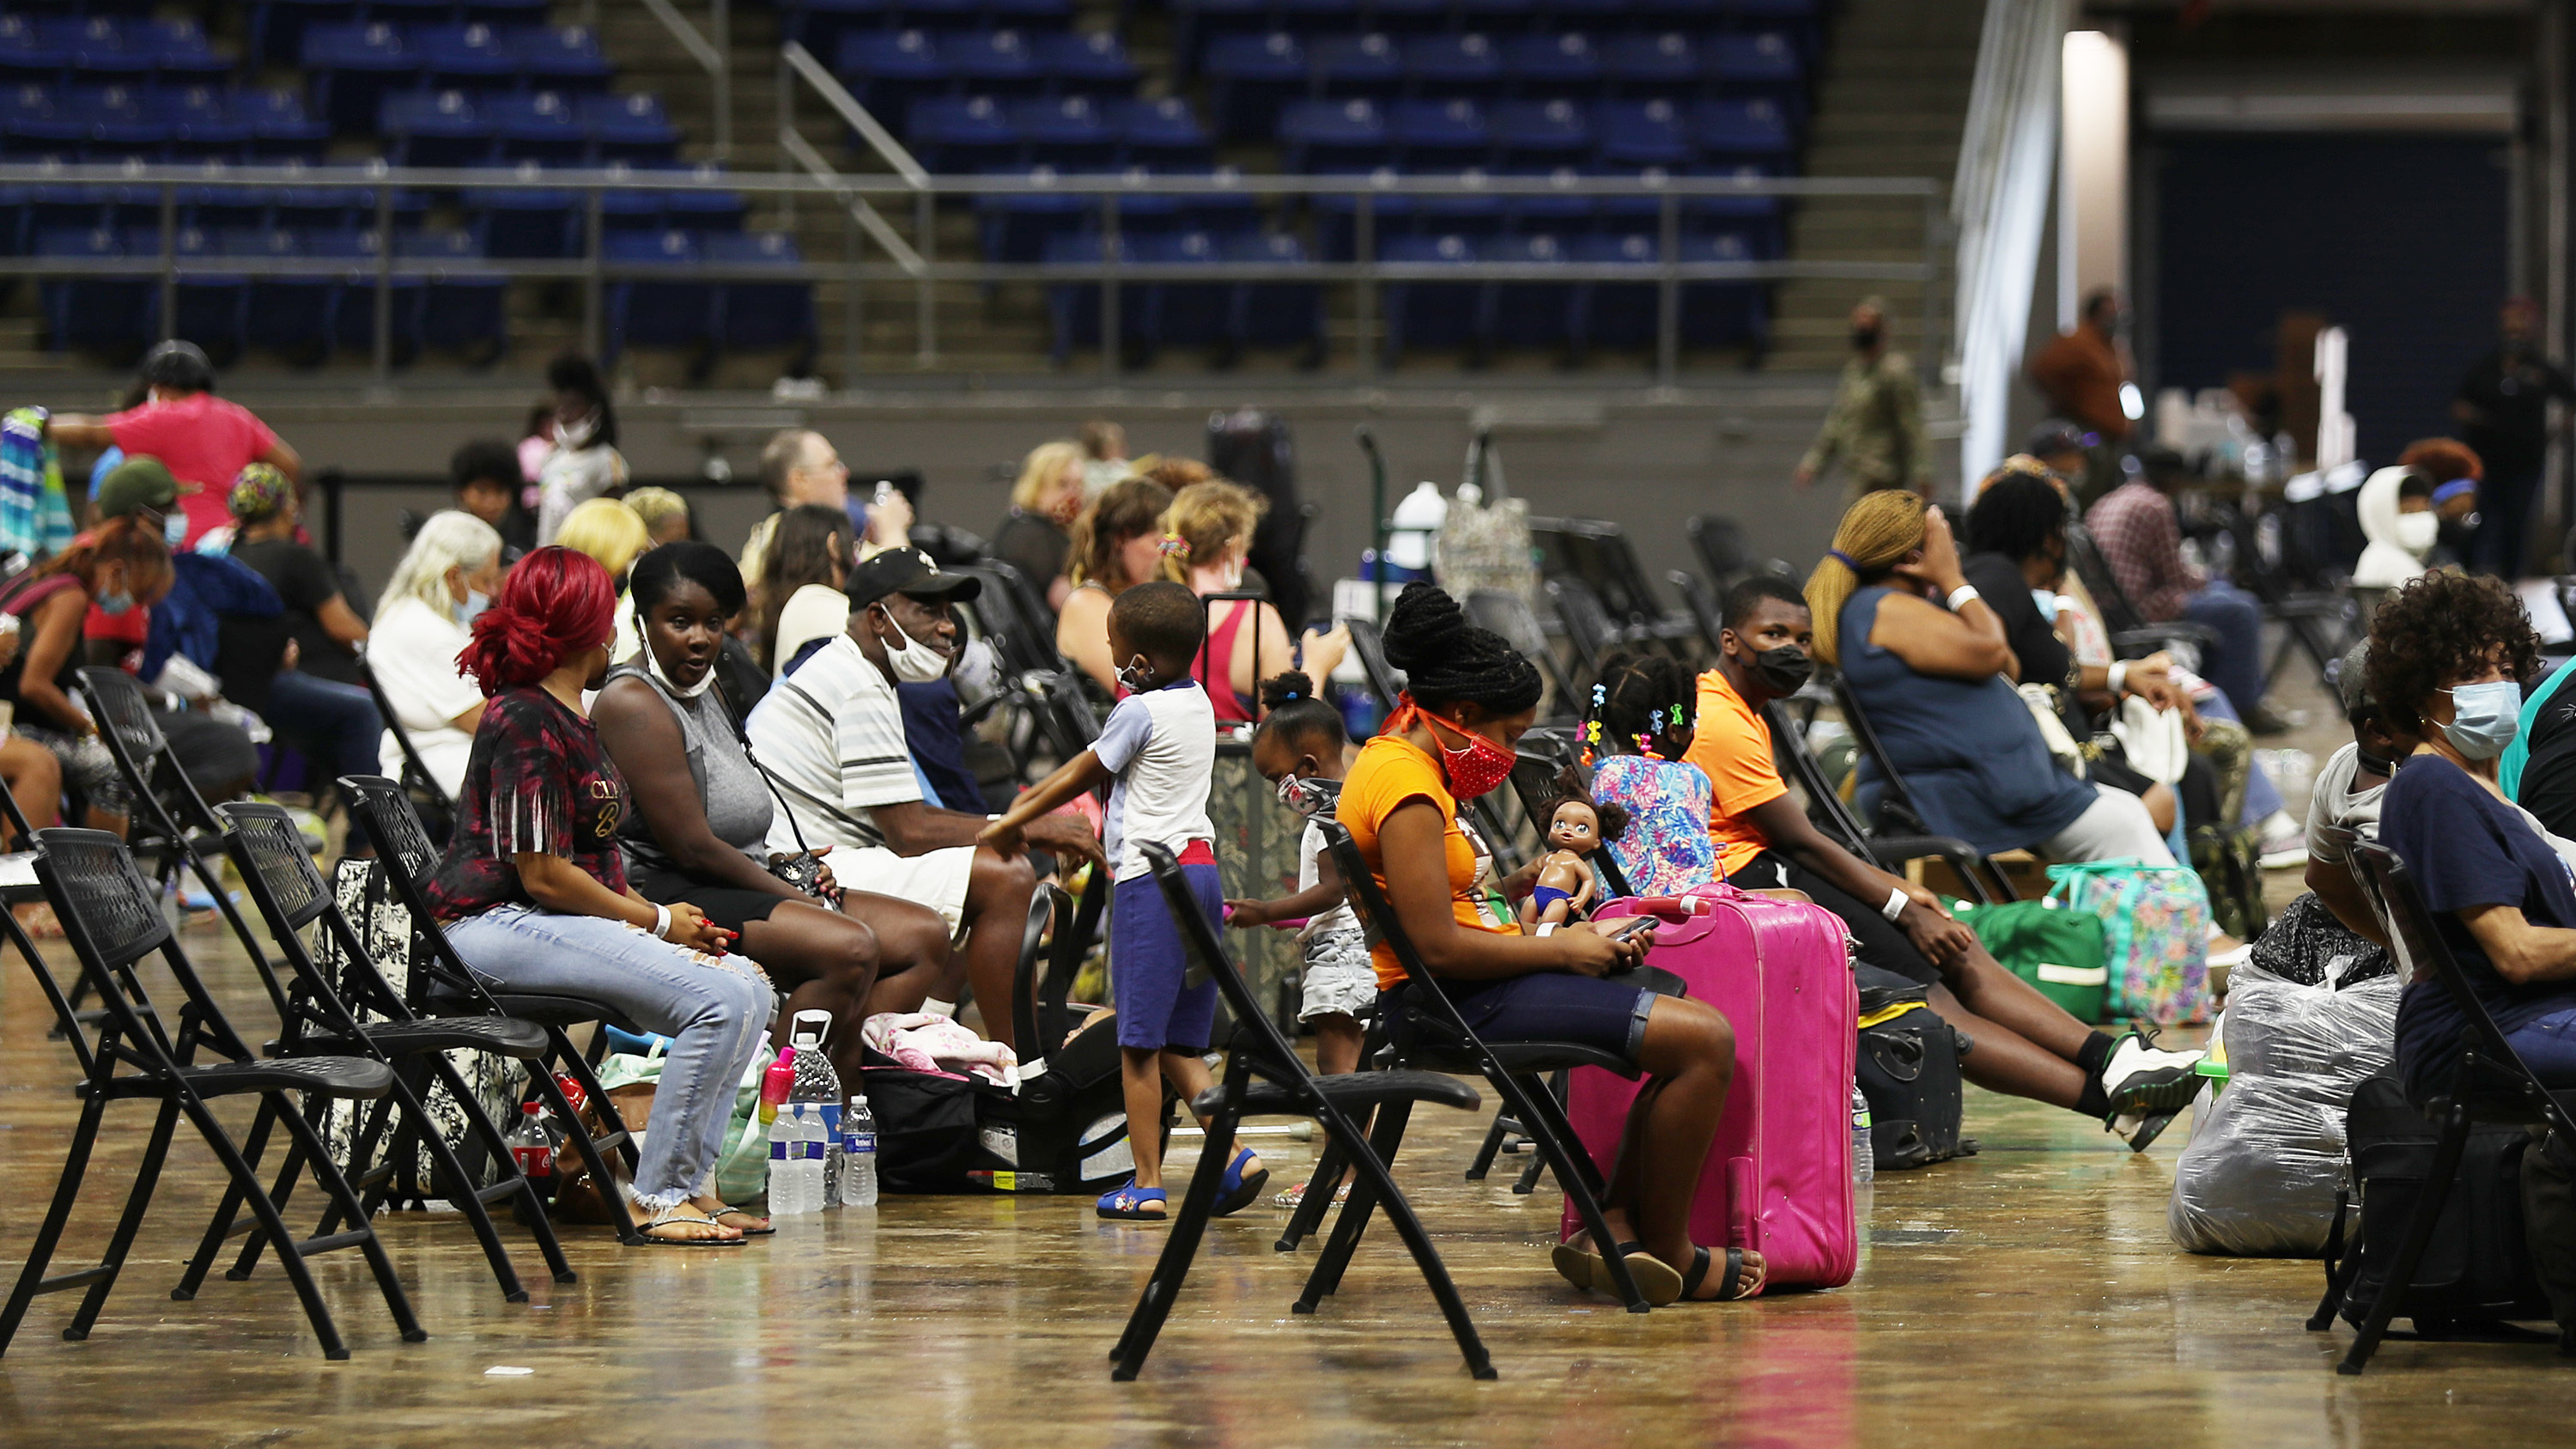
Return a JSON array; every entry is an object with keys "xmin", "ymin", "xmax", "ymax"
[{"xmin": 1226, "ymin": 670, "xmax": 1378, "ymax": 1207}]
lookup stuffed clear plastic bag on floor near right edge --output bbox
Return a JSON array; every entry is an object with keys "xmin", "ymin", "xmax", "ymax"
[{"xmin": 2166, "ymin": 965, "xmax": 2398, "ymax": 1258}]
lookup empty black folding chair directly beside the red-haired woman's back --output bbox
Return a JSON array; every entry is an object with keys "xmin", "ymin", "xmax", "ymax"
[{"xmin": 340, "ymin": 776, "xmax": 644, "ymax": 1243}]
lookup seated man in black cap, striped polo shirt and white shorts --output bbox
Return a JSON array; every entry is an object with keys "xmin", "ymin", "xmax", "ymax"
[{"xmin": 750, "ymin": 549, "xmax": 1100, "ymax": 1042}]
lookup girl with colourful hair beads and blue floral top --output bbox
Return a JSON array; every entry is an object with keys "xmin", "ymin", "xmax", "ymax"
[{"xmin": 1584, "ymin": 654, "xmax": 1718, "ymax": 895}]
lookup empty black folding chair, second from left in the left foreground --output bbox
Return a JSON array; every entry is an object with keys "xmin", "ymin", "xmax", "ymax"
[{"xmin": 180, "ymin": 802, "xmax": 574, "ymax": 1302}]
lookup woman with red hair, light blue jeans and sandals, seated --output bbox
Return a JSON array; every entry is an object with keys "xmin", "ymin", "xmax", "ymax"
[{"xmin": 430, "ymin": 546, "xmax": 773, "ymax": 1248}]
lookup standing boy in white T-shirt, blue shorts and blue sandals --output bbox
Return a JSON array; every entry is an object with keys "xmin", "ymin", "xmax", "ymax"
[{"xmin": 976, "ymin": 582, "xmax": 1270, "ymax": 1222}]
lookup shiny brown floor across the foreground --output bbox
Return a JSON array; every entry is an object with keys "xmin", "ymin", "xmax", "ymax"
[{"xmin": 0, "ymin": 912, "xmax": 2576, "ymax": 1449}]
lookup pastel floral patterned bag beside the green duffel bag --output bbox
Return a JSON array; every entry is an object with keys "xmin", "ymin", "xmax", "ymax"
[{"xmin": 2048, "ymin": 859, "xmax": 2210, "ymax": 1026}]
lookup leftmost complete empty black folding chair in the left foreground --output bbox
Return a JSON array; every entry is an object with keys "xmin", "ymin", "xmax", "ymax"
[{"xmin": 0, "ymin": 831, "xmax": 428, "ymax": 1359}]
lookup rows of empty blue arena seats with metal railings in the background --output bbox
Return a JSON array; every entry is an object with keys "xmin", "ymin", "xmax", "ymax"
[{"xmin": 0, "ymin": 0, "xmax": 1937, "ymax": 384}]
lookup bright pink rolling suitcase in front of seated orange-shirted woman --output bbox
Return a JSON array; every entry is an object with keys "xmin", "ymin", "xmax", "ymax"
[{"xmin": 1564, "ymin": 882, "xmax": 1860, "ymax": 1289}]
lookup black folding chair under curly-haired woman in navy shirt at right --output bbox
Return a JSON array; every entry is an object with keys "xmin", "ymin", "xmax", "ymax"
[{"xmin": 2308, "ymin": 831, "xmax": 2576, "ymax": 1374}]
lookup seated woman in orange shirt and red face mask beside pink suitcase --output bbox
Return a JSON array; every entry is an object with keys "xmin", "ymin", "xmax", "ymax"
[{"xmin": 1340, "ymin": 582, "xmax": 1762, "ymax": 1305}]
